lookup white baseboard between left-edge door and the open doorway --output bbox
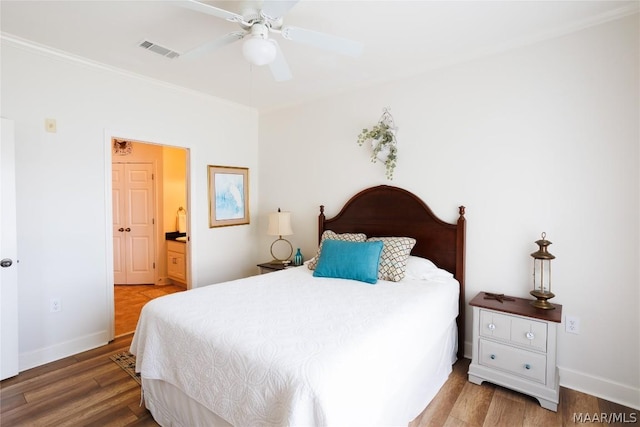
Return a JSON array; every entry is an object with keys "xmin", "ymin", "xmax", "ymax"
[{"xmin": 18, "ymin": 331, "xmax": 109, "ymax": 372}]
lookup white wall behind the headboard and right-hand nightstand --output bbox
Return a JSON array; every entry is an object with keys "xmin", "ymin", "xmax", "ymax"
[{"xmin": 259, "ymin": 15, "xmax": 640, "ymax": 408}]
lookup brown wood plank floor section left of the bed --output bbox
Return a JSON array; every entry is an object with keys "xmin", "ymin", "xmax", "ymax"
[{"xmin": 0, "ymin": 335, "xmax": 158, "ymax": 427}]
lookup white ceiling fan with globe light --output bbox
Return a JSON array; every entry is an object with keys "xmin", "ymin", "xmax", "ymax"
[{"xmin": 177, "ymin": 0, "xmax": 363, "ymax": 81}]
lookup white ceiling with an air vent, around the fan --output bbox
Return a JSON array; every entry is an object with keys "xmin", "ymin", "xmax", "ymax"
[{"xmin": 0, "ymin": 0, "xmax": 639, "ymax": 111}]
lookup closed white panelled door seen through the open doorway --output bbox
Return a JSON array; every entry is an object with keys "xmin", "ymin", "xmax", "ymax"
[{"xmin": 112, "ymin": 163, "xmax": 155, "ymax": 285}]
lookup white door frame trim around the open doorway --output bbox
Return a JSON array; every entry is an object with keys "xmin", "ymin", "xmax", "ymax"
[{"xmin": 103, "ymin": 129, "xmax": 195, "ymax": 341}]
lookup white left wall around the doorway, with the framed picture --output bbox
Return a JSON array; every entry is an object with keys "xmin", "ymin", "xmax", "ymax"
[{"xmin": 1, "ymin": 40, "xmax": 258, "ymax": 370}]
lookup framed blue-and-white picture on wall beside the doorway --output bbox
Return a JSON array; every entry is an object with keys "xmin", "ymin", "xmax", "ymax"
[{"xmin": 208, "ymin": 165, "xmax": 249, "ymax": 228}]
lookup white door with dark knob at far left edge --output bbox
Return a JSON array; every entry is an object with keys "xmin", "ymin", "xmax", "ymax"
[{"xmin": 0, "ymin": 119, "xmax": 18, "ymax": 380}]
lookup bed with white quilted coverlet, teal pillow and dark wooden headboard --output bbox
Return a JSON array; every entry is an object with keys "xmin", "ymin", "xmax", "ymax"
[{"xmin": 131, "ymin": 186, "xmax": 465, "ymax": 426}]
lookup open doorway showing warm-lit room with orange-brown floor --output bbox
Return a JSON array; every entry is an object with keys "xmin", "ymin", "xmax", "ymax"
[{"xmin": 110, "ymin": 137, "xmax": 190, "ymax": 336}]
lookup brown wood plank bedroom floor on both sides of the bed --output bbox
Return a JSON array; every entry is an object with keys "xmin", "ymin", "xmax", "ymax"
[{"xmin": 0, "ymin": 334, "xmax": 640, "ymax": 427}]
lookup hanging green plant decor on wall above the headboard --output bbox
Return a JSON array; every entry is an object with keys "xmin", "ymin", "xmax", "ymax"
[{"xmin": 358, "ymin": 108, "xmax": 398, "ymax": 180}]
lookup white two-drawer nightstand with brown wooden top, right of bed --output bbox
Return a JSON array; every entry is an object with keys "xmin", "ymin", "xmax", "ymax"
[{"xmin": 469, "ymin": 292, "xmax": 562, "ymax": 412}]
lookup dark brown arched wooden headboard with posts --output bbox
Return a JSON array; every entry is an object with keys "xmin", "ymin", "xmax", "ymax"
[{"xmin": 318, "ymin": 185, "xmax": 465, "ymax": 358}]
